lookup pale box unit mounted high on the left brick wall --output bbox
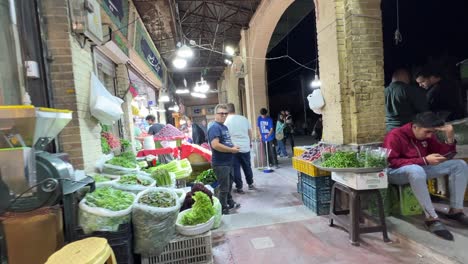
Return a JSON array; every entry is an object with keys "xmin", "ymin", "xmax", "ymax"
[{"xmin": 70, "ymin": 0, "xmax": 103, "ymax": 45}]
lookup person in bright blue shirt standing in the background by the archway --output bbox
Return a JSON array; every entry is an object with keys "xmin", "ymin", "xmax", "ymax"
[{"xmin": 257, "ymin": 108, "xmax": 279, "ymax": 168}]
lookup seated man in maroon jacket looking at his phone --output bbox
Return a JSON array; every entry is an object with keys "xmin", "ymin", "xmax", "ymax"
[{"xmin": 384, "ymin": 112, "xmax": 468, "ymax": 240}]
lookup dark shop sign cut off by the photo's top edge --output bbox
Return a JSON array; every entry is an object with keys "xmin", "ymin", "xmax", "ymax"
[{"xmin": 100, "ymin": 0, "xmax": 128, "ymax": 36}]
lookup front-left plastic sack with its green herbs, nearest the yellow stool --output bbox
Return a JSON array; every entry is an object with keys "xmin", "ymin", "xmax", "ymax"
[{"xmin": 78, "ymin": 187, "xmax": 135, "ymax": 234}]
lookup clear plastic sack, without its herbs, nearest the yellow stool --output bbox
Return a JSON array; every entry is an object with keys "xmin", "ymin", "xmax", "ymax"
[{"xmin": 78, "ymin": 193, "xmax": 136, "ymax": 234}]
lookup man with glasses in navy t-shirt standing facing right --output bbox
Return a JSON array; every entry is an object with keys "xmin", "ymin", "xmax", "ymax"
[{"xmin": 208, "ymin": 104, "xmax": 240, "ymax": 214}]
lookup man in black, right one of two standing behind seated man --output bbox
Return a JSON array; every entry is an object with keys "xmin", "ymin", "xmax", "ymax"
[{"xmin": 416, "ymin": 68, "xmax": 464, "ymax": 121}]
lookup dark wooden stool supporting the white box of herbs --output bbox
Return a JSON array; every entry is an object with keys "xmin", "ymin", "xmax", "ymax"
[{"xmin": 330, "ymin": 182, "xmax": 390, "ymax": 246}]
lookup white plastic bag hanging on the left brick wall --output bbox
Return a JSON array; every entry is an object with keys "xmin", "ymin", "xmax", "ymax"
[{"xmin": 89, "ymin": 73, "xmax": 124, "ymax": 125}]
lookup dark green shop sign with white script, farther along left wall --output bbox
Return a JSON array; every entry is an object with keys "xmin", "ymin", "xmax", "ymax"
[{"xmin": 134, "ymin": 21, "xmax": 164, "ymax": 81}]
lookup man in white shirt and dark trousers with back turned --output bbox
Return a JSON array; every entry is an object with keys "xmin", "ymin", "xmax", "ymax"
[{"xmin": 224, "ymin": 103, "xmax": 255, "ymax": 193}]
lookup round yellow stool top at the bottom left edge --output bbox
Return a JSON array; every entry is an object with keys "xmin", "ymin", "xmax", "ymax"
[{"xmin": 46, "ymin": 237, "xmax": 117, "ymax": 264}]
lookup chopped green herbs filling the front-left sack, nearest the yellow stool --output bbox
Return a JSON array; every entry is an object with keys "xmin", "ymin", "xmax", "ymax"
[{"xmin": 85, "ymin": 187, "xmax": 135, "ymax": 211}]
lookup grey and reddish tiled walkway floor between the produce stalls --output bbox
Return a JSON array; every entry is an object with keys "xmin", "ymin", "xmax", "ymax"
[{"xmin": 213, "ymin": 151, "xmax": 439, "ymax": 264}]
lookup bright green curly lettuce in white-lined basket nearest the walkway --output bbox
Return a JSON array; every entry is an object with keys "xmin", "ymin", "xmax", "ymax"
[{"xmin": 181, "ymin": 192, "xmax": 216, "ymax": 226}]
